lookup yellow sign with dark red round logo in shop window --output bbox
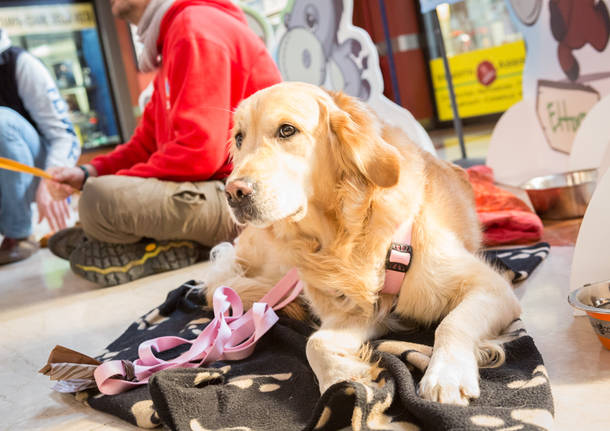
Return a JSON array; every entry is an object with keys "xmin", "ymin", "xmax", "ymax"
[{"xmin": 430, "ymin": 41, "xmax": 525, "ymax": 121}]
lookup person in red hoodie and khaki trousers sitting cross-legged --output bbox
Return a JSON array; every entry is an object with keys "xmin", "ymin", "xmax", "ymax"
[{"xmin": 49, "ymin": 0, "xmax": 281, "ymax": 286}]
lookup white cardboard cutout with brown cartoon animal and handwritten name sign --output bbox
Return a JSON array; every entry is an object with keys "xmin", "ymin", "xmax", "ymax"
[{"xmin": 487, "ymin": 0, "xmax": 610, "ymax": 186}]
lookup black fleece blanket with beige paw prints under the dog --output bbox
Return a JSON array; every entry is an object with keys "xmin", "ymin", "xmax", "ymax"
[{"xmin": 72, "ymin": 243, "xmax": 554, "ymax": 431}]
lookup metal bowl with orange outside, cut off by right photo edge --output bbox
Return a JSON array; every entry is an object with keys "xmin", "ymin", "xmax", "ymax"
[{"xmin": 568, "ymin": 280, "xmax": 610, "ymax": 350}]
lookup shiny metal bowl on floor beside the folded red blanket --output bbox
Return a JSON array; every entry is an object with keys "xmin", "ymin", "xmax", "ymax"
[{"xmin": 521, "ymin": 169, "xmax": 597, "ymax": 219}]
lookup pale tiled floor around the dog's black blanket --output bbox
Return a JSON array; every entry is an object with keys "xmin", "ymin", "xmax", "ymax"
[{"xmin": 0, "ymin": 130, "xmax": 610, "ymax": 431}]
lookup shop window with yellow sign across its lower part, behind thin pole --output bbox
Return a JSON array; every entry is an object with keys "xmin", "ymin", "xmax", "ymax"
[{"xmin": 424, "ymin": 0, "xmax": 525, "ymax": 121}]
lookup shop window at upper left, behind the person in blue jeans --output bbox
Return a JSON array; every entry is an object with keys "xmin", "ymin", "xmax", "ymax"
[{"xmin": 0, "ymin": 0, "xmax": 121, "ymax": 149}]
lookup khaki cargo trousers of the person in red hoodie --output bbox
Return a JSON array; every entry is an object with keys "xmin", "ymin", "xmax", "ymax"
[{"xmin": 79, "ymin": 175, "xmax": 238, "ymax": 247}]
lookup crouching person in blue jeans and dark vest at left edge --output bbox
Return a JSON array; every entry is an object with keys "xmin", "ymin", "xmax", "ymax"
[{"xmin": 0, "ymin": 29, "xmax": 80, "ymax": 265}]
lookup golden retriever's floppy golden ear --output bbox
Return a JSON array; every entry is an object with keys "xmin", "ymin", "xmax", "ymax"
[{"xmin": 328, "ymin": 92, "xmax": 400, "ymax": 187}]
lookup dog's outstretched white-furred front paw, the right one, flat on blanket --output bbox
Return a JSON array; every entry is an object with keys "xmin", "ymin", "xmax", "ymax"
[{"xmin": 419, "ymin": 352, "xmax": 480, "ymax": 406}]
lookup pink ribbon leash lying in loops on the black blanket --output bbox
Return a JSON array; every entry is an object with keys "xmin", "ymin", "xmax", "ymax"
[{"xmin": 93, "ymin": 268, "xmax": 303, "ymax": 395}]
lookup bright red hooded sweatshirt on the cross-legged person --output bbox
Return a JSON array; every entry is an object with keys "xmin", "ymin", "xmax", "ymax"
[{"xmin": 91, "ymin": 0, "xmax": 281, "ymax": 181}]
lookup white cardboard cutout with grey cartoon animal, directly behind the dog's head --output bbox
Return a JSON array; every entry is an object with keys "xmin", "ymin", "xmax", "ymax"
[{"xmin": 272, "ymin": 0, "xmax": 435, "ymax": 154}]
